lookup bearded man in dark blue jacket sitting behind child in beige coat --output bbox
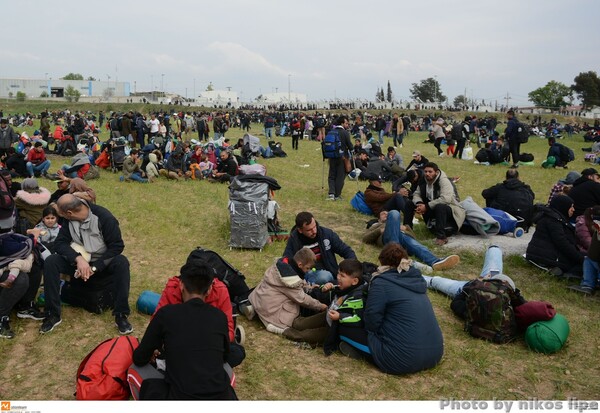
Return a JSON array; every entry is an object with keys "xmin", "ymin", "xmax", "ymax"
[{"xmin": 283, "ymin": 212, "xmax": 356, "ymax": 285}]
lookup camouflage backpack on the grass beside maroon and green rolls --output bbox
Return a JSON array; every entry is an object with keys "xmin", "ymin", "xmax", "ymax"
[{"xmin": 463, "ymin": 279, "xmax": 517, "ymax": 344}]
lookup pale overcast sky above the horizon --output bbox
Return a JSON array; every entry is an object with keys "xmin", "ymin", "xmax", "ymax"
[{"xmin": 0, "ymin": 0, "xmax": 600, "ymax": 106}]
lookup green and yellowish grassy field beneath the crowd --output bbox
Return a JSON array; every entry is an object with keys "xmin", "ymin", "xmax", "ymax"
[{"xmin": 0, "ymin": 107, "xmax": 600, "ymax": 400}]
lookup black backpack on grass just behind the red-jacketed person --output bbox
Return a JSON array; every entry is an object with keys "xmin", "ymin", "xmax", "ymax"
[{"xmin": 186, "ymin": 247, "xmax": 251, "ymax": 304}]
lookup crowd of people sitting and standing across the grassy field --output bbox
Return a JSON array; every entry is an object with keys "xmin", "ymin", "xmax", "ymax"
[{"xmin": 0, "ymin": 107, "xmax": 600, "ymax": 399}]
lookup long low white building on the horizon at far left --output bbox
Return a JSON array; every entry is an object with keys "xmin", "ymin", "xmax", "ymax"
[{"xmin": 0, "ymin": 79, "xmax": 131, "ymax": 99}]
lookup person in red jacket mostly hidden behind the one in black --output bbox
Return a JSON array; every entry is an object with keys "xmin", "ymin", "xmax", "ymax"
[{"xmin": 152, "ymin": 260, "xmax": 246, "ymax": 367}]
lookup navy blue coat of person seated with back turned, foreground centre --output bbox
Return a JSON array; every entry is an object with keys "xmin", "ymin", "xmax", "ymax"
[{"xmin": 364, "ymin": 268, "xmax": 444, "ymax": 374}]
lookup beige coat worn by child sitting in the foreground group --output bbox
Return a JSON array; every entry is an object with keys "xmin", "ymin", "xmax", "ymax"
[{"xmin": 248, "ymin": 259, "xmax": 323, "ymax": 328}]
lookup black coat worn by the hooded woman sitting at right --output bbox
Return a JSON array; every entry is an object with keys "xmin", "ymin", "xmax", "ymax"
[{"xmin": 526, "ymin": 205, "xmax": 584, "ymax": 271}]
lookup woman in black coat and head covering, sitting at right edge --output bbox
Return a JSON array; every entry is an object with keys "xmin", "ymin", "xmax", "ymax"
[{"xmin": 526, "ymin": 195, "xmax": 584, "ymax": 277}]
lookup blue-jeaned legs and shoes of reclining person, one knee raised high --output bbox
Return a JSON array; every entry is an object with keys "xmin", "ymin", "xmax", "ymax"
[{"xmin": 362, "ymin": 211, "xmax": 460, "ymax": 272}]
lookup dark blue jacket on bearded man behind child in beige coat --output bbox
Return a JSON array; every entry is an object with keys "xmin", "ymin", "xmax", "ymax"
[{"xmin": 283, "ymin": 222, "xmax": 356, "ymax": 277}]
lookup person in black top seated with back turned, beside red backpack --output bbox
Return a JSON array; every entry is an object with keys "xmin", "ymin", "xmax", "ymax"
[{"xmin": 131, "ymin": 263, "xmax": 237, "ymax": 400}]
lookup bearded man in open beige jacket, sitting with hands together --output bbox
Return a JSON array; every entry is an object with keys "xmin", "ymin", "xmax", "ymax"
[{"xmin": 413, "ymin": 162, "xmax": 466, "ymax": 245}]
